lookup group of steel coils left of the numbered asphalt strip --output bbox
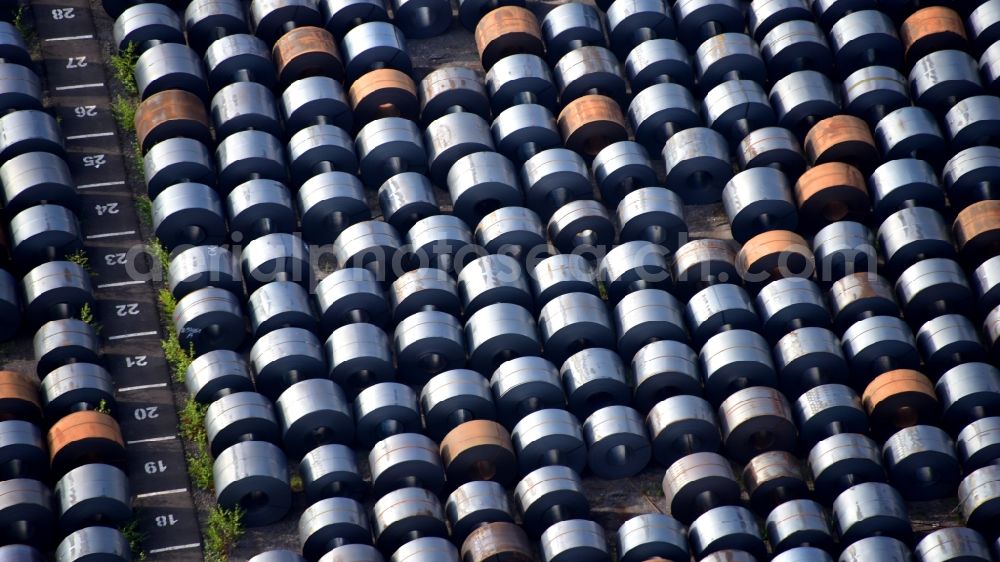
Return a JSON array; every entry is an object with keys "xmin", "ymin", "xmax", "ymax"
[{"xmin": 0, "ymin": 8, "xmax": 139, "ymax": 562}]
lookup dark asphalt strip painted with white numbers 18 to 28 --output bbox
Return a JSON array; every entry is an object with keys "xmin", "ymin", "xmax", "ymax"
[{"xmin": 30, "ymin": 0, "xmax": 202, "ymax": 562}]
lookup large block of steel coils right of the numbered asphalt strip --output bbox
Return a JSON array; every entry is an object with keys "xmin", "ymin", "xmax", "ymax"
[{"xmin": 5, "ymin": 0, "xmax": 1000, "ymax": 561}]
